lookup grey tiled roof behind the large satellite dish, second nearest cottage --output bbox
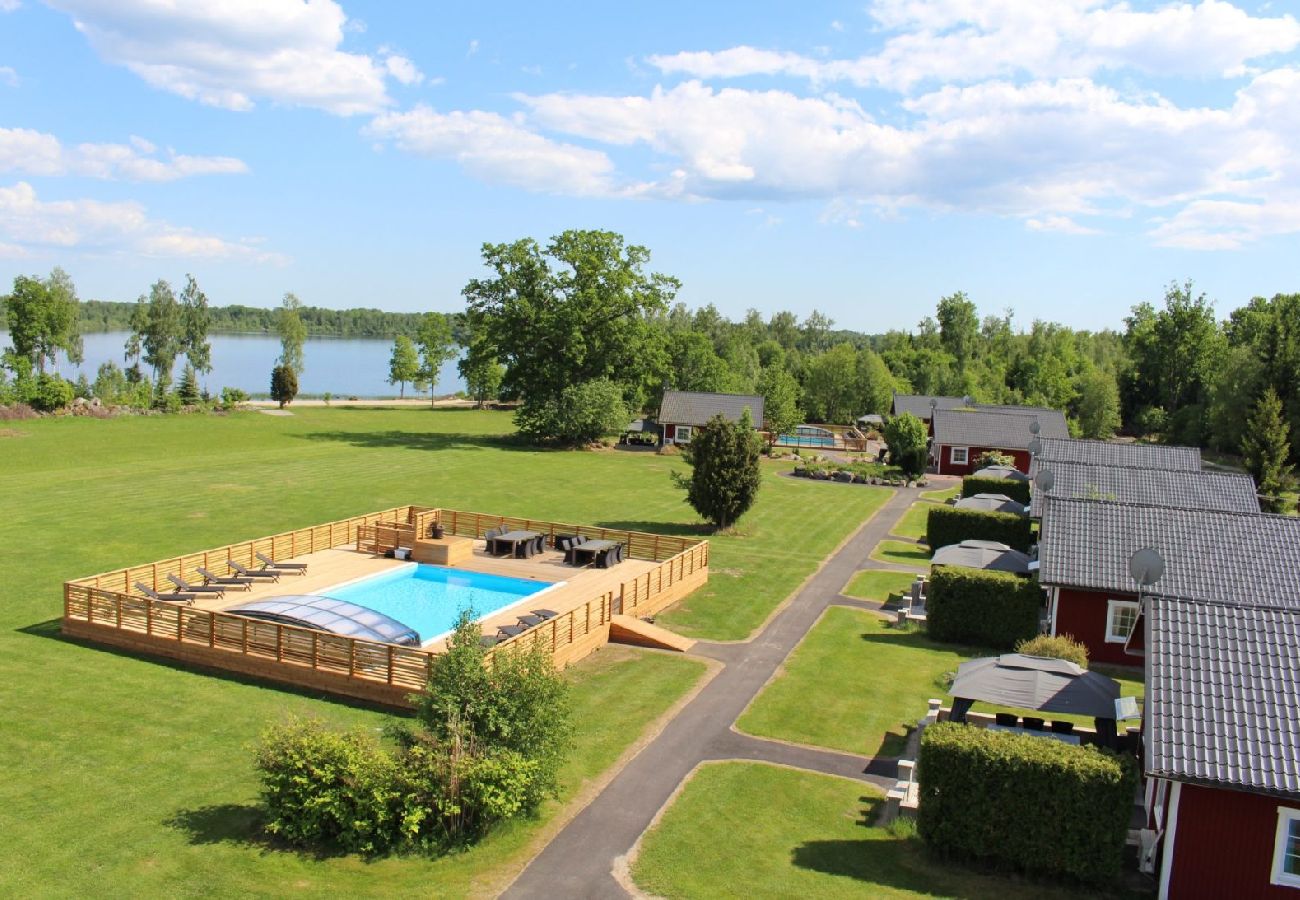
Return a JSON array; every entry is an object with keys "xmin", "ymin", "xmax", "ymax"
[{"xmin": 1039, "ymin": 497, "xmax": 1300, "ymax": 606}]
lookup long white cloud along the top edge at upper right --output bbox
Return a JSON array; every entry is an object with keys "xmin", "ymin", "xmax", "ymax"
[{"xmin": 649, "ymin": 0, "xmax": 1300, "ymax": 92}]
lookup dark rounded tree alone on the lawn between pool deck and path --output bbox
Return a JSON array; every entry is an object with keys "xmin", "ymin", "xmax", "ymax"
[{"xmin": 673, "ymin": 410, "xmax": 763, "ymax": 529}]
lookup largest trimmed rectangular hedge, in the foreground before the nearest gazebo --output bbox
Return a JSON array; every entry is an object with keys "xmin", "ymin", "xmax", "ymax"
[{"xmin": 917, "ymin": 722, "xmax": 1138, "ymax": 884}]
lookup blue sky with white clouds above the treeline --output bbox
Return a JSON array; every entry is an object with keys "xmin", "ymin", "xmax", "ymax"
[{"xmin": 0, "ymin": 0, "xmax": 1300, "ymax": 332}]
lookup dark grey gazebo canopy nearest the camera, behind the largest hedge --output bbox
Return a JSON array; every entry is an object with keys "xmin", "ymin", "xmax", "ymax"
[{"xmin": 949, "ymin": 653, "xmax": 1119, "ymax": 722}]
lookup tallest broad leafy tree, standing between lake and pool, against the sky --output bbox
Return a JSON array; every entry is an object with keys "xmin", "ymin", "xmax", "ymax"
[{"xmin": 463, "ymin": 230, "xmax": 679, "ymax": 434}]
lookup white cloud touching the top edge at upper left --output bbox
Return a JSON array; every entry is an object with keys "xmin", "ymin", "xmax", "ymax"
[{"xmin": 49, "ymin": 0, "xmax": 395, "ymax": 116}]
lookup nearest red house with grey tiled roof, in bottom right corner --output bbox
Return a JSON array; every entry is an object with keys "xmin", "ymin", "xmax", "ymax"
[{"xmin": 1141, "ymin": 592, "xmax": 1300, "ymax": 900}]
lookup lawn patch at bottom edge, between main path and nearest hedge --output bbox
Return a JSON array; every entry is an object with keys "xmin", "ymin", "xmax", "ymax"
[{"xmin": 632, "ymin": 762, "xmax": 1084, "ymax": 900}]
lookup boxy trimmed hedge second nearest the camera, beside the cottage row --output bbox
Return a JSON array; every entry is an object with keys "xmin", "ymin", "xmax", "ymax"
[{"xmin": 926, "ymin": 566, "xmax": 1043, "ymax": 650}]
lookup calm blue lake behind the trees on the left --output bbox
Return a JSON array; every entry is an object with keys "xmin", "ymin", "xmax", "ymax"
[{"xmin": 0, "ymin": 332, "xmax": 465, "ymax": 398}]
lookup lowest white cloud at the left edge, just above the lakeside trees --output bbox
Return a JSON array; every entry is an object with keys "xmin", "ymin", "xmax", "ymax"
[{"xmin": 0, "ymin": 181, "xmax": 285, "ymax": 263}]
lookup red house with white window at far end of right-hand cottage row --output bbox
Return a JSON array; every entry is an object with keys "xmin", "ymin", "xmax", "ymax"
[{"xmin": 930, "ymin": 406, "xmax": 1070, "ymax": 475}]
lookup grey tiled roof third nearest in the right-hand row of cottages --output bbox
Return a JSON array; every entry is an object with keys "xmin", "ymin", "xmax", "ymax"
[{"xmin": 1031, "ymin": 462, "xmax": 1260, "ymax": 516}]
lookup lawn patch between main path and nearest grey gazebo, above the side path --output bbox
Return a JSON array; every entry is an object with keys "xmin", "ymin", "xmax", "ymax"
[{"xmin": 736, "ymin": 606, "xmax": 1143, "ymax": 756}]
